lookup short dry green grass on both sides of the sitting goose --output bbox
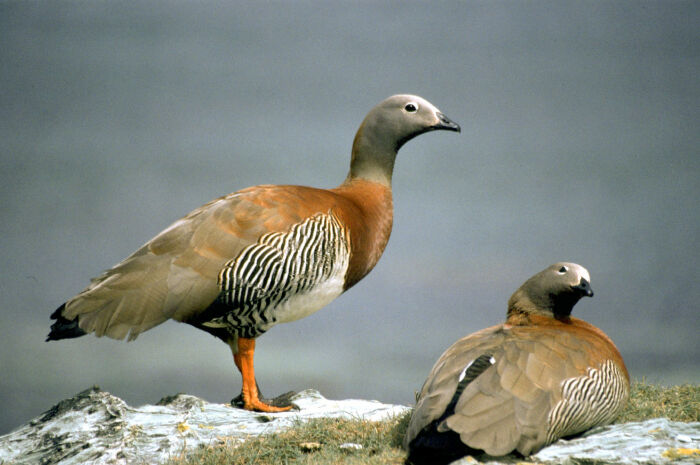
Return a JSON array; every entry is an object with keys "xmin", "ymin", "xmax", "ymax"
[{"xmin": 167, "ymin": 381, "xmax": 700, "ymax": 465}]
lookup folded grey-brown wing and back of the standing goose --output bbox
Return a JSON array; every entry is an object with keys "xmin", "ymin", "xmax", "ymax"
[{"xmin": 63, "ymin": 186, "xmax": 334, "ymax": 340}]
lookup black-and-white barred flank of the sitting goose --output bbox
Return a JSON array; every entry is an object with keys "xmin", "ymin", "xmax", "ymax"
[{"xmin": 547, "ymin": 360, "xmax": 629, "ymax": 444}]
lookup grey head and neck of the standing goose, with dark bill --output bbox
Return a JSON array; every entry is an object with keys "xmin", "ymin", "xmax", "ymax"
[{"xmin": 348, "ymin": 94, "xmax": 460, "ymax": 185}]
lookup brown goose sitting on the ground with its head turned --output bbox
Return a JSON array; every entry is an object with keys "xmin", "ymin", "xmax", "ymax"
[{"xmin": 404, "ymin": 262, "xmax": 630, "ymax": 464}]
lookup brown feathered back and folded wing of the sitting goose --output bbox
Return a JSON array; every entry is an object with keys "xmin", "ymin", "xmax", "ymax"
[{"xmin": 406, "ymin": 320, "xmax": 616, "ymax": 455}]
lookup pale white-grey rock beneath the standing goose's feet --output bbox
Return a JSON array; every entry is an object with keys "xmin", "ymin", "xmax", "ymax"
[{"xmin": 0, "ymin": 387, "xmax": 408, "ymax": 465}]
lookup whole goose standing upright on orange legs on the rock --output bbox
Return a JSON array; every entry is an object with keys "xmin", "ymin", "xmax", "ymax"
[{"xmin": 46, "ymin": 95, "xmax": 460, "ymax": 412}]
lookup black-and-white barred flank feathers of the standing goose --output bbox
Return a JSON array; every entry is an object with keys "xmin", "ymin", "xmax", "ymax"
[{"xmin": 205, "ymin": 212, "xmax": 349, "ymax": 338}]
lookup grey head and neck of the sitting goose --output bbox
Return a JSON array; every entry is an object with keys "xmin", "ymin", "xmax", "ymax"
[{"xmin": 508, "ymin": 262, "xmax": 593, "ymax": 319}]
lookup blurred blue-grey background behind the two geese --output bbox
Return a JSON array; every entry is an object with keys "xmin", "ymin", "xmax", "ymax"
[{"xmin": 0, "ymin": 1, "xmax": 700, "ymax": 433}]
